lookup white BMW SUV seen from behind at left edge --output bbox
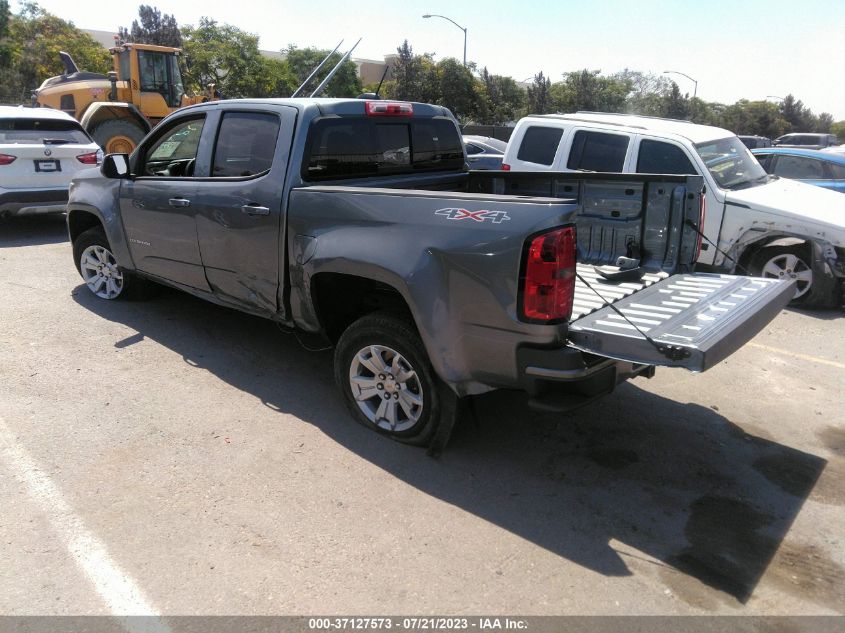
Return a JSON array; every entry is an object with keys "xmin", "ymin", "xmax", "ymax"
[{"xmin": 0, "ymin": 106, "xmax": 103, "ymax": 217}]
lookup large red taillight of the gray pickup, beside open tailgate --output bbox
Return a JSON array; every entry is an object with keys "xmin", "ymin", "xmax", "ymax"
[{"xmin": 522, "ymin": 226, "xmax": 577, "ymax": 323}]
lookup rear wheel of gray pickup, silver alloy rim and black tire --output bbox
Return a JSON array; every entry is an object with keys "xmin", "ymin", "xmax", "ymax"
[{"xmin": 334, "ymin": 312, "xmax": 442, "ymax": 446}]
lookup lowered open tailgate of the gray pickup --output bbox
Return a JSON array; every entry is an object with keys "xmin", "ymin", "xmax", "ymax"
[{"xmin": 569, "ymin": 273, "xmax": 795, "ymax": 371}]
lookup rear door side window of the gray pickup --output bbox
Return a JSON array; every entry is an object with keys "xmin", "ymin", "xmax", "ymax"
[{"xmin": 211, "ymin": 112, "xmax": 280, "ymax": 178}]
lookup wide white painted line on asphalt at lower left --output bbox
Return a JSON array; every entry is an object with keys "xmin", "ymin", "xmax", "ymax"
[{"xmin": 0, "ymin": 417, "xmax": 169, "ymax": 633}]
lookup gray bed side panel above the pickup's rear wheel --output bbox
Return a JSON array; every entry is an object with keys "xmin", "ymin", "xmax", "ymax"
[{"xmin": 288, "ymin": 188, "xmax": 574, "ymax": 395}]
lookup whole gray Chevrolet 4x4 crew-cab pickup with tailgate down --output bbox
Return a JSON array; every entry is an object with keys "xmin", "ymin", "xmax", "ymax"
[{"xmin": 67, "ymin": 99, "xmax": 794, "ymax": 445}]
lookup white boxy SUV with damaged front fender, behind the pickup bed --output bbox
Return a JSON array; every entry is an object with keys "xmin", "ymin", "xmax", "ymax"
[{"xmin": 502, "ymin": 112, "xmax": 845, "ymax": 306}]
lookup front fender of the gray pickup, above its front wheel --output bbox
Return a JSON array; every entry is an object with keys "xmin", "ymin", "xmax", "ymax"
[{"xmin": 67, "ymin": 169, "xmax": 135, "ymax": 270}]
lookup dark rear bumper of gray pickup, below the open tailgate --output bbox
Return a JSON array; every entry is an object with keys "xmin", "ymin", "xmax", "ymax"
[{"xmin": 517, "ymin": 347, "xmax": 655, "ymax": 412}]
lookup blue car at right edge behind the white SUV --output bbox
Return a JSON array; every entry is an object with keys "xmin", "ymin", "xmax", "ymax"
[{"xmin": 751, "ymin": 147, "xmax": 845, "ymax": 193}]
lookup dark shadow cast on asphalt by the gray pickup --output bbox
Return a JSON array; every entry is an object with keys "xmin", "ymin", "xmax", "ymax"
[{"xmin": 73, "ymin": 286, "xmax": 842, "ymax": 608}]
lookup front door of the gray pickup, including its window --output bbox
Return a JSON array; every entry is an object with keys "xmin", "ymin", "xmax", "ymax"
[{"xmin": 120, "ymin": 116, "xmax": 209, "ymax": 290}]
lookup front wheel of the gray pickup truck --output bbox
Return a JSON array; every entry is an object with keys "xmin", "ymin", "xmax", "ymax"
[{"xmin": 73, "ymin": 227, "xmax": 142, "ymax": 301}]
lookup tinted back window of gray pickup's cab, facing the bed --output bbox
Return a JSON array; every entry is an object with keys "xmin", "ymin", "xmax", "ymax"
[{"xmin": 302, "ymin": 117, "xmax": 464, "ymax": 180}]
